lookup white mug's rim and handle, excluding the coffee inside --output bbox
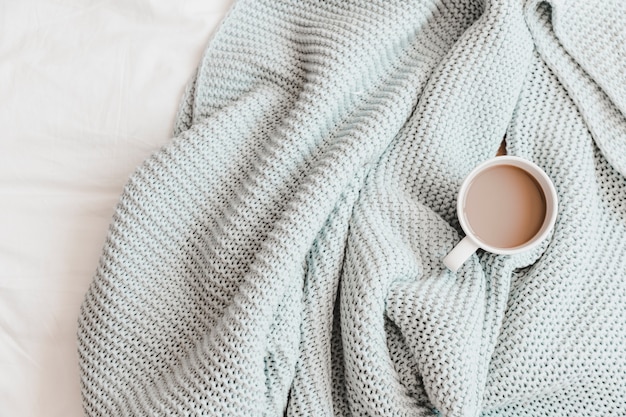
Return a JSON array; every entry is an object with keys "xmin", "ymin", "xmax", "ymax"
[{"xmin": 443, "ymin": 156, "xmax": 558, "ymax": 272}]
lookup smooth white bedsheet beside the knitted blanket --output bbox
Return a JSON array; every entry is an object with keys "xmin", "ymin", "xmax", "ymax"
[{"xmin": 0, "ymin": 0, "xmax": 232, "ymax": 417}]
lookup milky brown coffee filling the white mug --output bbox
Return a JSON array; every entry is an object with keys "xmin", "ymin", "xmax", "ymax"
[{"xmin": 464, "ymin": 165, "xmax": 546, "ymax": 248}]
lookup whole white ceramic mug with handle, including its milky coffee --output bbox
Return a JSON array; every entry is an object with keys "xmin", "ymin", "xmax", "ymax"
[{"xmin": 443, "ymin": 156, "xmax": 558, "ymax": 272}]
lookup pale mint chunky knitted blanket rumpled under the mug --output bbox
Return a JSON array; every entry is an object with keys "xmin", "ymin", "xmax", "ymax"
[{"xmin": 78, "ymin": 0, "xmax": 626, "ymax": 416}]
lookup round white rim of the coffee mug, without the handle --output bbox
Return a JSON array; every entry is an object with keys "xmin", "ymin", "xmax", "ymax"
[{"xmin": 457, "ymin": 155, "xmax": 558, "ymax": 255}]
